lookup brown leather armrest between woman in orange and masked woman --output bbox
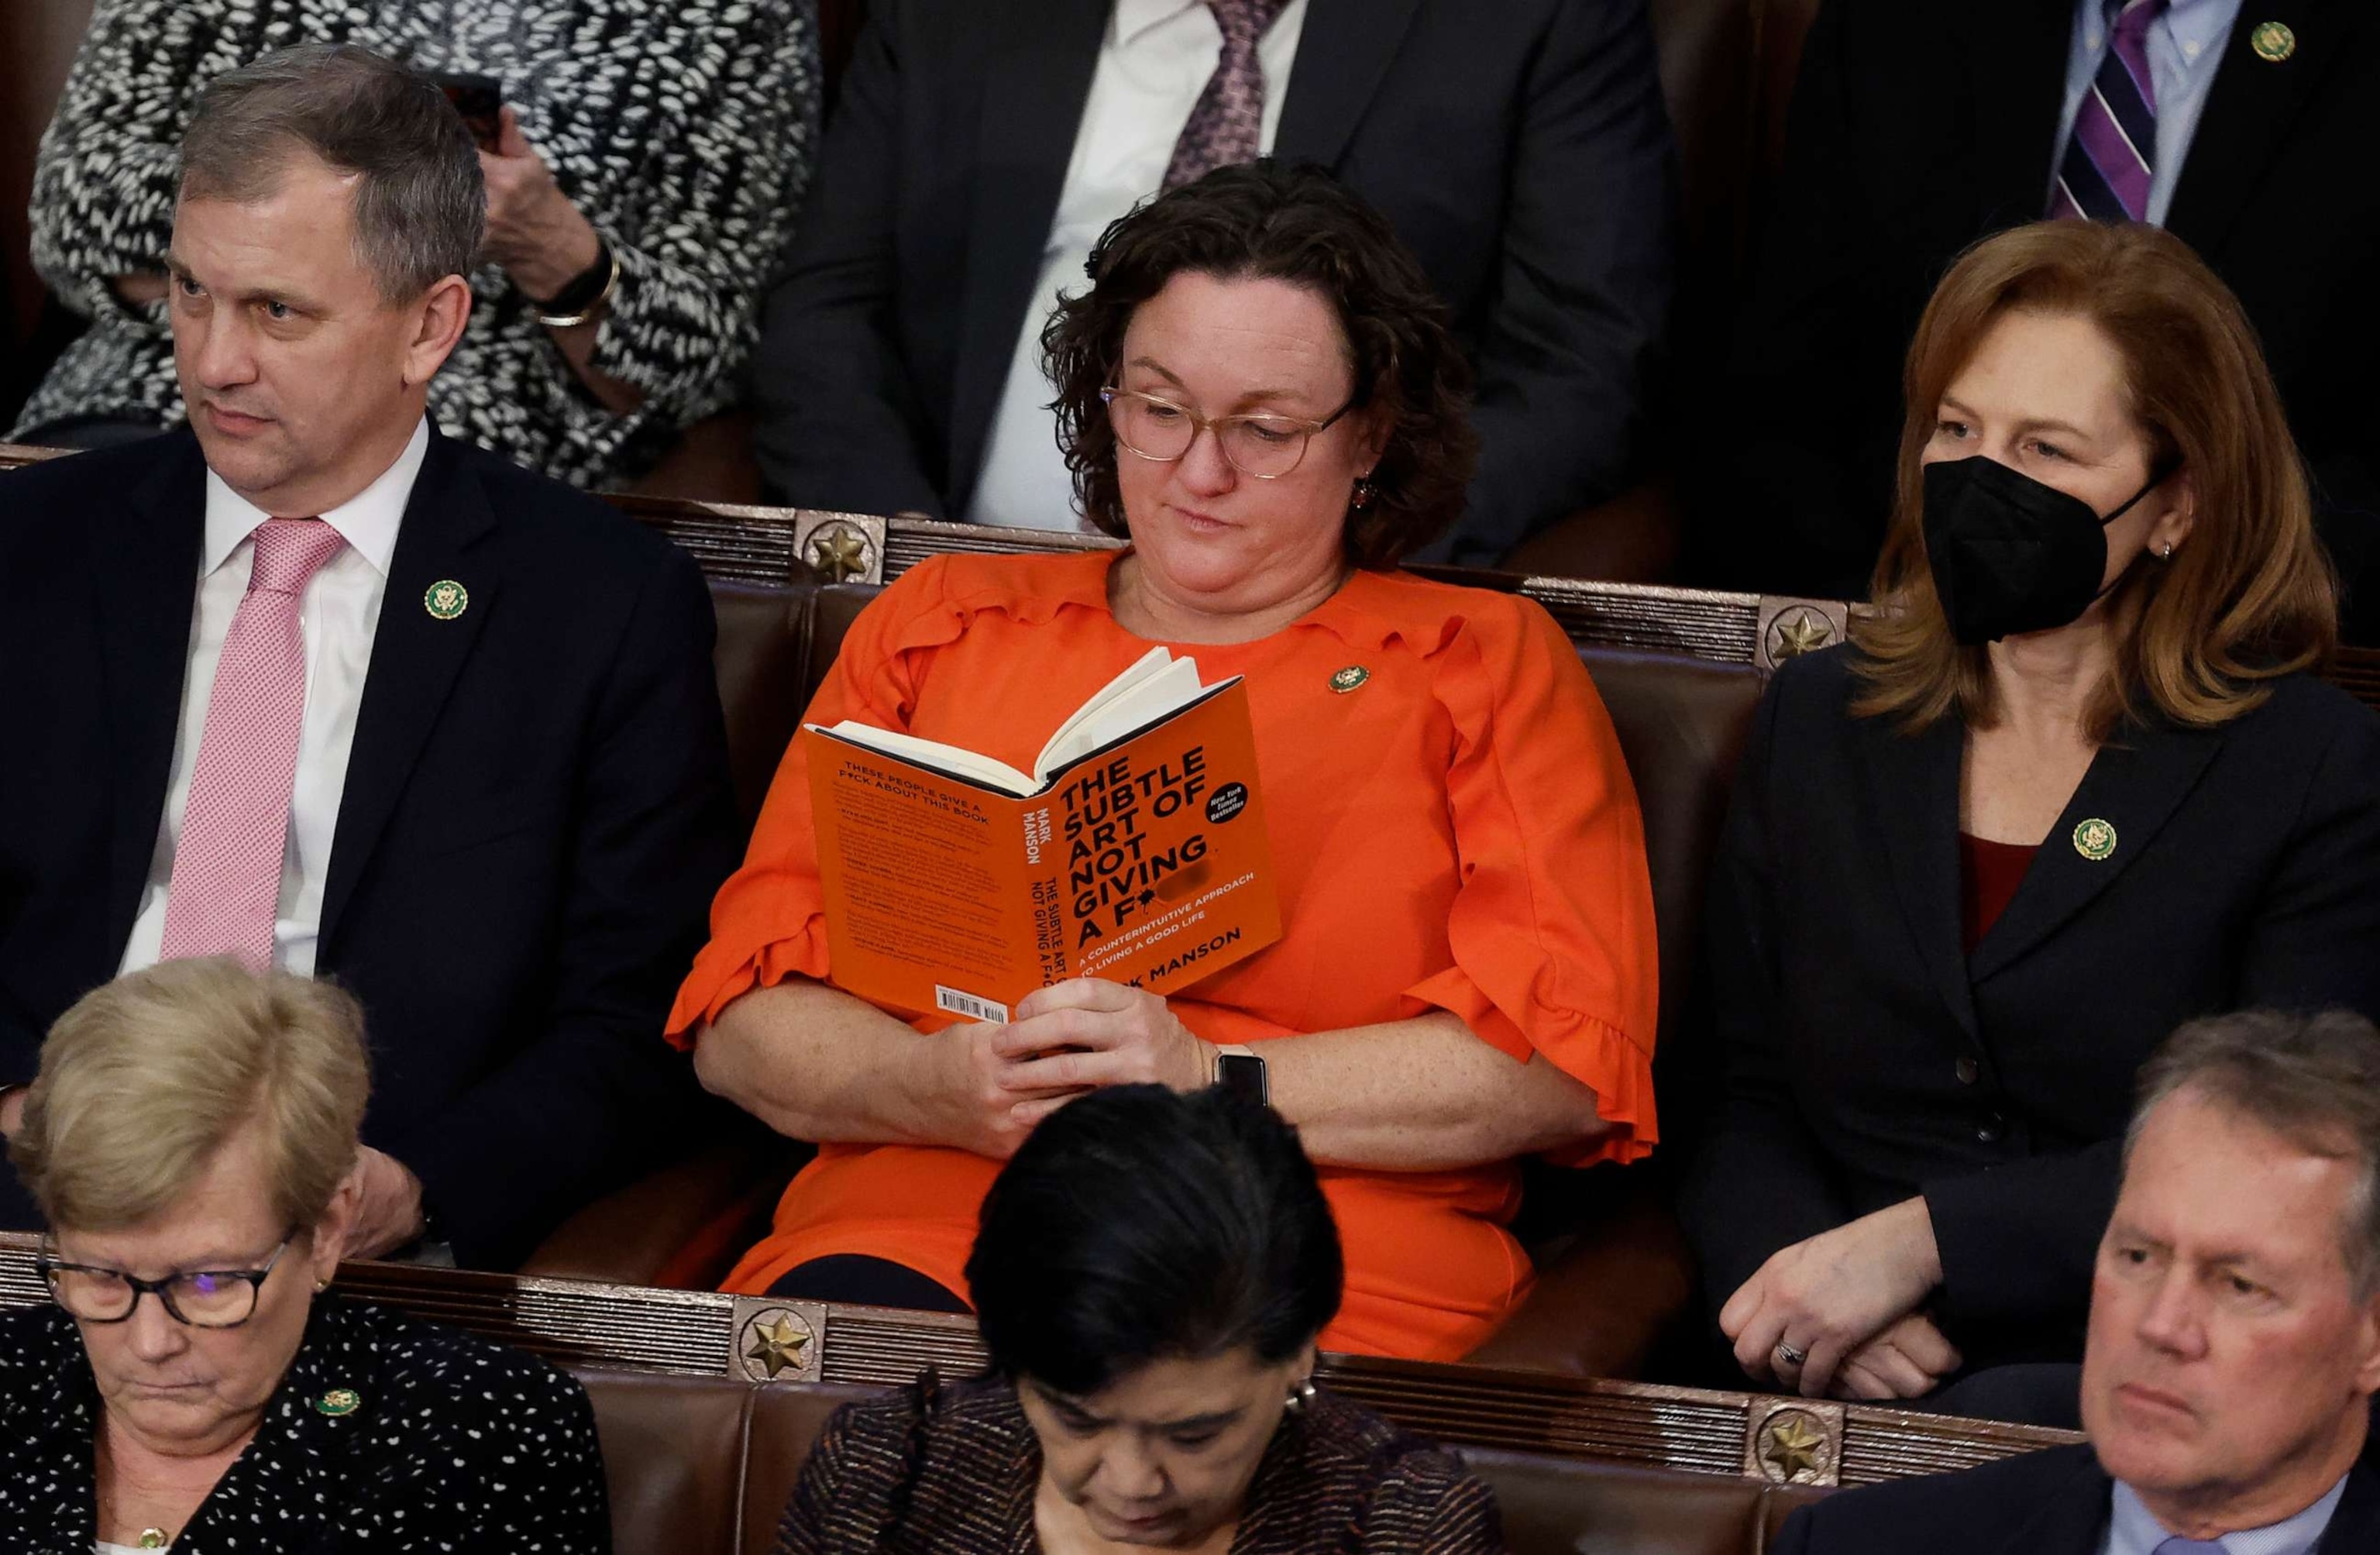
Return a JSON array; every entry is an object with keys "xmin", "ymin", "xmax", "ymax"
[{"xmin": 1466, "ymin": 1167, "xmax": 1694, "ymax": 1379}]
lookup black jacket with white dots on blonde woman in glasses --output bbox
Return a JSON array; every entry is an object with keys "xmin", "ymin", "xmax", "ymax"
[{"xmin": 0, "ymin": 1295, "xmax": 612, "ymax": 1555}]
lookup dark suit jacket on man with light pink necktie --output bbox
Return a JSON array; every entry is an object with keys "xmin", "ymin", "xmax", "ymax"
[{"xmin": 0, "ymin": 431, "xmax": 735, "ymax": 1267}]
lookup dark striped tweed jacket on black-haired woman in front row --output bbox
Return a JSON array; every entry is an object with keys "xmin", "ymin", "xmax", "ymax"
[{"xmin": 776, "ymin": 1371, "xmax": 1505, "ymax": 1555}]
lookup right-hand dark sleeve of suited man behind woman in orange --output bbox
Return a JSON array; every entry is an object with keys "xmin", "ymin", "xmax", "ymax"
[{"xmin": 1447, "ymin": 0, "xmax": 1678, "ymax": 564}]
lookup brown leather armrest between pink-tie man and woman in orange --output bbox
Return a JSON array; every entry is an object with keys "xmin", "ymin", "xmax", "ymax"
[{"xmin": 521, "ymin": 1140, "xmax": 807, "ymax": 1291}]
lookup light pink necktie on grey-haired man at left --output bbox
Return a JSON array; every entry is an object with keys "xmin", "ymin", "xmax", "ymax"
[{"xmin": 164, "ymin": 519, "xmax": 345, "ymax": 972}]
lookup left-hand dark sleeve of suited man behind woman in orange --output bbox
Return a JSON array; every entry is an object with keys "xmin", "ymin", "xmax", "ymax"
[{"xmin": 750, "ymin": 5, "xmax": 964, "ymax": 517}]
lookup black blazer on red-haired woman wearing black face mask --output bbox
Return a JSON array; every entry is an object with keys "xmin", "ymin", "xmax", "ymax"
[{"xmin": 1685, "ymin": 648, "xmax": 2380, "ymax": 1367}]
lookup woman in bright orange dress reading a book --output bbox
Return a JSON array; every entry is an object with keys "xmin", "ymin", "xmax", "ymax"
[{"xmin": 669, "ymin": 164, "xmax": 1654, "ymax": 1360}]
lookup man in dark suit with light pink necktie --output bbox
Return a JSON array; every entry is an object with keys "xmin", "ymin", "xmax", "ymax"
[{"xmin": 0, "ymin": 45, "xmax": 735, "ymax": 1264}]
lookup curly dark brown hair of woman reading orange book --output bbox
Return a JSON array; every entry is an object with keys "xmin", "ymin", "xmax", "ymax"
[{"xmin": 1043, "ymin": 160, "xmax": 1478, "ymax": 569}]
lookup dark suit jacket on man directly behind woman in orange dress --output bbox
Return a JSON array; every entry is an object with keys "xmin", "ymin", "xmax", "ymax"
[{"xmin": 752, "ymin": 0, "xmax": 1676, "ymax": 562}]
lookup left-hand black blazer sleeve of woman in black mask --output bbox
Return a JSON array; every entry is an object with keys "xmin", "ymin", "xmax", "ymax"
[{"xmin": 1680, "ymin": 676, "xmax": 1852, "ymax": 1307}]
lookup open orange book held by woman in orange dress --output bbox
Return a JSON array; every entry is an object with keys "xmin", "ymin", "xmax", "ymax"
[{"xmin": 797, "ymin": 650, "xmax": 1281, "ymax": 1022}]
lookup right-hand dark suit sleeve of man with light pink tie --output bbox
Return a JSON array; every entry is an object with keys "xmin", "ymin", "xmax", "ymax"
[{"xmin": 390, "ymin": 550, "xmax": 735, "ymax": 1269}]
